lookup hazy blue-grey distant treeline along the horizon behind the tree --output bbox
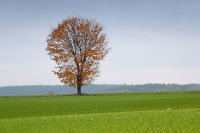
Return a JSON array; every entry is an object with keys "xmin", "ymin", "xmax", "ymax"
[{"xmin": 0, "ymin": 84, "xmax": 200, "ymax": 96}]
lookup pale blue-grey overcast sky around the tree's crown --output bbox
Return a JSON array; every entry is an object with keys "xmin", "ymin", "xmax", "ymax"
[{"xmin": 0, "ymin": 0, "xmax": 200, "ymax": 86}]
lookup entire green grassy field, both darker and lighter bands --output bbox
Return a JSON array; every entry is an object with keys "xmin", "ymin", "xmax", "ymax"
[{"xmin": 0, "ymin": 91, "xmax": 200, "ymax": 133}]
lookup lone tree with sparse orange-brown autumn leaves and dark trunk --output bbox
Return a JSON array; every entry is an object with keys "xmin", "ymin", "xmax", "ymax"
[{"xmin": 46, "ymin": 17, "xmax": 109, "ymax": 95}]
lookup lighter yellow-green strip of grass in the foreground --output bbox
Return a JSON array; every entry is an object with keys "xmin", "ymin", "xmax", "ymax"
[{"xmin": 0, "ymin": 109, "xmax": 200, "ymax": 133}]
